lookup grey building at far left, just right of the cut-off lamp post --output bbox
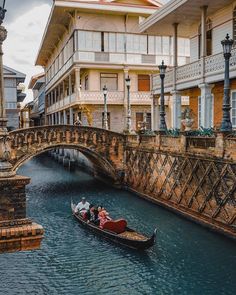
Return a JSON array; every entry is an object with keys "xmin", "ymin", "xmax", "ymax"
[{"xmin": 3, "ymin": 66, "xmax": 26, "ymax": 130}]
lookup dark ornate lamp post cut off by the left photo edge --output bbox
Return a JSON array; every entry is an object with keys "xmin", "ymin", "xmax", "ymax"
[{"xmin": 0, "ymin": 0, "xmax": 7, "ymax": 132}]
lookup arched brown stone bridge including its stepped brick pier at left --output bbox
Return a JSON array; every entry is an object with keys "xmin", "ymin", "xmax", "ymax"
[{"xmin": 0, "ymin": 125, "xmax": 125, "ymax": 252}]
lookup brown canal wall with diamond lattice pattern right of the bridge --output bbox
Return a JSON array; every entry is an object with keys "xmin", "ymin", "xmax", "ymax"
[{"xmin": 126, "ymin": 136, "xmax": 236, "ymax": 238}]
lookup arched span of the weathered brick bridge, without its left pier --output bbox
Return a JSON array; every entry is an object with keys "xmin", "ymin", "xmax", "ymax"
[{"xmin": 9, "ymin": 125, "xmax": 125, "ymax": 182}]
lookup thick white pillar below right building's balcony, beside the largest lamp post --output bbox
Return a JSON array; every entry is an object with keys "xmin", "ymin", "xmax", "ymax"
[{"xmin": 198, "ymin": 84, "xmax": 213, "ymax": 128}]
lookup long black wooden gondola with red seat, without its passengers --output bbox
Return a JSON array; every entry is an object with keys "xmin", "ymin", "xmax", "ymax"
[{"xmin": 71, "ymin": 200, "xmax": 157, "ymax": 250}]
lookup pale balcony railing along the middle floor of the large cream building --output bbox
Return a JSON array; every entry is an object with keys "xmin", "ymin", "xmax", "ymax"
[{"xmin": 47, "ymin": 91, "xmax": 151, "ymax": 113}]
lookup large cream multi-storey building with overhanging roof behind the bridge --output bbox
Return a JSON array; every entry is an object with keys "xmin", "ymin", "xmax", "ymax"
[{"xmin": 36, "ymin": 0, "xmax": 189, "ymax": 132}]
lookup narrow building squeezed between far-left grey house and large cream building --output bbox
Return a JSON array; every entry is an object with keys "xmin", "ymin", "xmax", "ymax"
[{"xmin": 28, "ymin": 73, "xmax": 45, "ymax": 126}]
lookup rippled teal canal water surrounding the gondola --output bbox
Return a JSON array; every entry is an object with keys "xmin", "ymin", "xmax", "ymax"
[{"xmin": 0, "ymin": 155, "xmax": 236, "ymax": 295}]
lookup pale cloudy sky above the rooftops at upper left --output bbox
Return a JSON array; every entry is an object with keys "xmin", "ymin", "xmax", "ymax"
[{"xmin": 0, "ymin": 0, "xmax": 168, "ymax": 101}]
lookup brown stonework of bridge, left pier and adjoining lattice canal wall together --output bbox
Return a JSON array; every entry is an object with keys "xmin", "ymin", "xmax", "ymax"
[{"xmin": 0, "ymin": 125, "xmax": 236, "ymax": 252}]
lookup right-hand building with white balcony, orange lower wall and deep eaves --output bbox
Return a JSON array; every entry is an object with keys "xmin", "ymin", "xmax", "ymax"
[{"xmin": 141, "ymin": 0, "xmax": 236, "ymax": 128}]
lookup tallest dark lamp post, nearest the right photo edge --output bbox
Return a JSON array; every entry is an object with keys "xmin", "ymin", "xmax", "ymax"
[{"xmin": 220, "ymin": 34, "xmax": 234, "ymax": 132}]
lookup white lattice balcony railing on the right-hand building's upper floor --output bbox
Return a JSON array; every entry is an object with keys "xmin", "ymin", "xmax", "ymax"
[{"xmin": 153, "ymin": 49, "xmax": 236, "ymax": 91}]
